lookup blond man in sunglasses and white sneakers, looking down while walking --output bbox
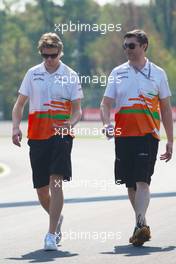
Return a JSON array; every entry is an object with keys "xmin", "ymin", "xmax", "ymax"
[{"xmin": 12, "ymin": 33, "xmax": 83, "ymax": 250}]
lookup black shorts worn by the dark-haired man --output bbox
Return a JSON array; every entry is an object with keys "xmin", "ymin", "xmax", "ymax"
[{"xmin": 115, "ymin": 134, "xmax": 159, "ymax": 189}]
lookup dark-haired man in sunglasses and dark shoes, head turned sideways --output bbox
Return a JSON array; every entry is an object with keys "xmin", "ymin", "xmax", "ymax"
[{"xmin": 101, "ymin": 29, "xmax": 173, "ymax": 246}]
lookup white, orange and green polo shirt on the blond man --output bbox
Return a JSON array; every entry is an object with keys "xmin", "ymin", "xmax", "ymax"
[{"xmin": 19, "ymin": 62, "xmax": 83, "ymax": 140}]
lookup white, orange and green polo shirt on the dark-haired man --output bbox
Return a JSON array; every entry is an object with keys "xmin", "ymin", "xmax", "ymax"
[{"xmin": 104, "ymin": 60, "xmax": 171, "ymax": 139}]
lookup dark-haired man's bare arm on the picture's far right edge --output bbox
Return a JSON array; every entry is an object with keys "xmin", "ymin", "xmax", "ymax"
[{"xmin": 160, "ymin": 97, "xmax": 173, "ymax": 162}]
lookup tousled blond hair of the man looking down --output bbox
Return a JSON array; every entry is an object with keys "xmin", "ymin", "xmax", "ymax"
[{"xmin": 38, "ymin": 32, "xmax": 64, "ymax": 55}]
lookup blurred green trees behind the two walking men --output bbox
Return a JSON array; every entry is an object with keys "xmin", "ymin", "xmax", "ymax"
[{"xmin": 0, "ymin": 0, "xmax": 176, "ymax": 119}]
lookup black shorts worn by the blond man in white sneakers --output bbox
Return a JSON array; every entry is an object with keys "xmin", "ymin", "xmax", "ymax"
[{"xmin": 28, "ymin": 135, "xmax": 73, "ymax": 188}]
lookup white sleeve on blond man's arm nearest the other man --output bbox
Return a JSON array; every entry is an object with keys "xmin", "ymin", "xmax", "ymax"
[{"xmin": 71, "ymin": 74, "xmax": 84, "ymax": 101}]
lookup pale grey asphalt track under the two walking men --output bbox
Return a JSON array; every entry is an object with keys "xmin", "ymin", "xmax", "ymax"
[{"xmin": 0, "ymin": 122, "xmax": 176, "ymax": 264}]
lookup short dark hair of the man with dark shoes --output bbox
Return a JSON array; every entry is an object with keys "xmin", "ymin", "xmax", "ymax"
[{"xmin": 124, "ymin": 29, "xmax": 149, "ymax": 51}]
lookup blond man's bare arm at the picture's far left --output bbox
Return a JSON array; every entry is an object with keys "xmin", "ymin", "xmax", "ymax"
[{"xmin": 12, "ymin": 94, "xmax": 28, "ymax": 147}]
